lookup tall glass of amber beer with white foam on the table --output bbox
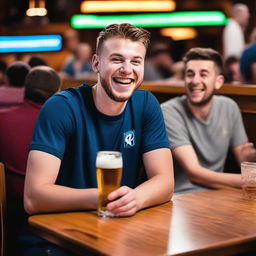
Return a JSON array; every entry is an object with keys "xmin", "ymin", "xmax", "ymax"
[{"xmin": 96, "ymin": 151, "xmax": 123, "ymax": 217}]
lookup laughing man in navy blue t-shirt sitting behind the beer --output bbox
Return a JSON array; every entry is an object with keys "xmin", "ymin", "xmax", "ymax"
[{"xmin": 24, "ymin": 23, "xmax": 173, "ymax": 255}]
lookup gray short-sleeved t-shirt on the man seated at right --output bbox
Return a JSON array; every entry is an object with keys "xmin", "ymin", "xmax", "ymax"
[{"xmin": 161, "ymin": 95, "xmax": 248, "ymax": 192}]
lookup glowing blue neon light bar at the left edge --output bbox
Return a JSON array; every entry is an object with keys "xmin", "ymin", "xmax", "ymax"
[{"xmin": 0, "ymin": 35, "xmax": 62, "ymax": 53}]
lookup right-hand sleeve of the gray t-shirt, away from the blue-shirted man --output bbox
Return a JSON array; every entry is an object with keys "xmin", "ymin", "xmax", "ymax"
[{"xmin": 230, "ymin": 101, "xmax": 248, "ymax": 147}]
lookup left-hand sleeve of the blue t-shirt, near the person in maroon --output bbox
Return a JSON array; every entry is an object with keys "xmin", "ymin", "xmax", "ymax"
[{"xmin": 30, "ymin": 95, "xmax": 73, "ymax": 159}]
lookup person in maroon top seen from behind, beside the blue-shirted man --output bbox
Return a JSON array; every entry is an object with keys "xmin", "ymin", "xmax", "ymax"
[{"xmin": 0, "ymin": 66, "xmax": 61, "ymax": 255}]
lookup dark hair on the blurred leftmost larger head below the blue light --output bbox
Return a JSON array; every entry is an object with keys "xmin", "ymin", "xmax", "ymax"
[{"xmin": 6, "ymin": 61, "xmax": 30, "ymax": 87}]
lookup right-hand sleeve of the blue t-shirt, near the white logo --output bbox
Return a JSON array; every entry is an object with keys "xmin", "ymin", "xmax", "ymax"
[{"xmin": 142, "ymin": 93, "xmax": 170, "ymax": 153}]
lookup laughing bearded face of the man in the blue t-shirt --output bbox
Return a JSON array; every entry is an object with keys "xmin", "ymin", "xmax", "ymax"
[{"xmin": 93, "ymin": 37, "xmax": 146, "ymax": 102}]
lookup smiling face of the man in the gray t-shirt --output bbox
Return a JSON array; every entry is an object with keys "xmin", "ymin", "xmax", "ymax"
[{"xmin": 185, "ymin": 60, "xmax": 223, "ymax": 106}]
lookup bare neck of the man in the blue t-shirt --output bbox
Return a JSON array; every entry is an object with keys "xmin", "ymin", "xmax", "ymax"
[{"xmin": 92, "ymin": 83, "xmax": 127, "ymax": 116}]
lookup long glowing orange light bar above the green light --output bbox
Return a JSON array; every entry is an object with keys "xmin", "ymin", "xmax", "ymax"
[{"xmin": 80, "ymin": 0, "xmax": 176, "ymax": 13}]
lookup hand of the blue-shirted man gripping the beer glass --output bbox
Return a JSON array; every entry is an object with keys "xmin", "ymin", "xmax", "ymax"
[{"xmin": 107, "ymin": 186, "xmax": 139, "ymax": 216}]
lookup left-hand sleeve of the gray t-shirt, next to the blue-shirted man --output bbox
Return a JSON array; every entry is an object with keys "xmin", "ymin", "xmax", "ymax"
[{"xmin": 161, "ymin": 100, "xmax": 191, "ymax": 149}]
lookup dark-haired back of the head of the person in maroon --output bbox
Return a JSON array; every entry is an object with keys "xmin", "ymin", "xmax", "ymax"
[{"xmin": 25, "ymin": 66, "xmax": 61, "ymax": 103}]
